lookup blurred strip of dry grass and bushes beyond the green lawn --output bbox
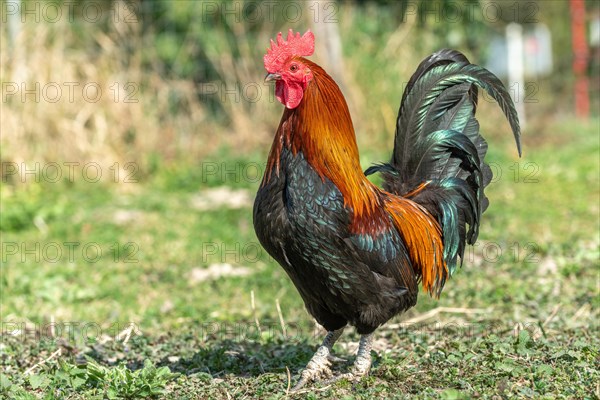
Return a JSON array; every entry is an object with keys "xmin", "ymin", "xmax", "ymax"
[{"xmin": 1, "ymin": 0, "xmax": 600, "ymax": 171}]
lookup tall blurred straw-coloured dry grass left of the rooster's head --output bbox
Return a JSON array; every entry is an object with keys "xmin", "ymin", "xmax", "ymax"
[{"xmin": 0, "ymin": 2, "xmax": 277, "ymax": 178}]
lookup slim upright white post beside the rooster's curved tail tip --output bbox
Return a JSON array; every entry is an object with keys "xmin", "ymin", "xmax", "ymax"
[{"xmin": 506, "ymin": 23, "xmax": 526, "ymax": 130}]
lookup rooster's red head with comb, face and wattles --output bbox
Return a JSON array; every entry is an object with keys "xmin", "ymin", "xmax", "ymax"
[{"xmin": 263, "ymin": 29, "xmax": 315, "ymax": 109}]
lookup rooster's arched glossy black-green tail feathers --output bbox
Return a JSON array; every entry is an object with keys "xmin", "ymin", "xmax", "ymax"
[{"xmin": 365, "ymin": 49, "xmax": 521, "ymax": 273}]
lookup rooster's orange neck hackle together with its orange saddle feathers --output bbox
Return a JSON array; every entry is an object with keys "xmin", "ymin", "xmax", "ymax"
[{"xmin": 263, "ymin": 57, "xmax": 447, "ymax": 295}]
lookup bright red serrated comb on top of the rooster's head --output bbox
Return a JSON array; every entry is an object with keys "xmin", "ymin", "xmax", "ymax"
[{"xmin": 263, "ymin": 29, "xmax": 315, "ymax": 73}]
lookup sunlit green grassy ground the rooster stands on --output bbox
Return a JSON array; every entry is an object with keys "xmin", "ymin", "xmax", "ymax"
[{"xmin": 0, "ymin": 120, "xmax": 600, "ymax": 399}]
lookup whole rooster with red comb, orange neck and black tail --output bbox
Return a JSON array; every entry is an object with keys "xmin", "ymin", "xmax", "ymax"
[{"xmin": 253, "ymin": 29, "xmax": 521, "ymax": 390}]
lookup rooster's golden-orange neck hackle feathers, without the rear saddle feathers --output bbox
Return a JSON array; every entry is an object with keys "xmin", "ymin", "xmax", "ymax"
[{"xmin": 267, "ymin": 57, "xmax": 386, "ymax": 233}]
